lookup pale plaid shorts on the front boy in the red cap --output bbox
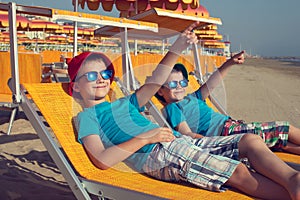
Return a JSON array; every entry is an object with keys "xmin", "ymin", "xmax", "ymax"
[{"xmin": 143, "ymin": 134, "xmax": 243, "ymax": 191}]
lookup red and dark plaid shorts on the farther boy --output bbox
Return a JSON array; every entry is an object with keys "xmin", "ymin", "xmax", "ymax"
[{"xmin": 221, "ymin": 119, "xmax": 290, "ymax": 150}]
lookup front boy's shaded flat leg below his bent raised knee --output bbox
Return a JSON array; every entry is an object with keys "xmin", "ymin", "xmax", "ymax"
[{"xmin": 225, "ymin": 164, "xmax": 291, "ymax": 200}]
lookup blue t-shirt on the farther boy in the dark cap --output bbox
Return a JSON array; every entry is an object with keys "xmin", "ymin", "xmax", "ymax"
[{"xmin": 163, "ymin": 90, "xmax": 229, "ymax": 136}]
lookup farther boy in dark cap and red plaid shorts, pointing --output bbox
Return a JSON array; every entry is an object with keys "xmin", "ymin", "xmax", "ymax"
[{"xmin": 155, "ymin": 51, "xmax": 300, "ymax": 155}]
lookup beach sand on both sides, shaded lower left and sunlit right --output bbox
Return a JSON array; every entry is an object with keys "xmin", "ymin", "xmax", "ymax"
[{"xmin": 0, "ymin": 58, "xmax": 300, "ymax": 200}]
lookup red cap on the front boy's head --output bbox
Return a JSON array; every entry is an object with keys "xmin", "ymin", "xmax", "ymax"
[{"xmin": 68, "ymin": 52, "xmax": 115, "ymax": 96}]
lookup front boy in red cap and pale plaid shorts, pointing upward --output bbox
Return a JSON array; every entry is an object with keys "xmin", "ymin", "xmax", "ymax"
[{"xmin": 68, "ymin": 23, "xmax": 300, "ymax": 199}]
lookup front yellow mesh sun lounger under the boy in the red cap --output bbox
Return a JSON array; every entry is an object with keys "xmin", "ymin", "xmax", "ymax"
[{"xmin": 21, "ymin": 83, "xmax": 258, "ymax": 199}]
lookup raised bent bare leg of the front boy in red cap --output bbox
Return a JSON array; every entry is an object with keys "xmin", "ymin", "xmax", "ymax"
[{"xmin": 239, "ymin": 134, "xmax": 300, "ymax": 200}]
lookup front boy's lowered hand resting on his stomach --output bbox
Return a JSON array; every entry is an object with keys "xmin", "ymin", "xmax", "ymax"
[{"xmin": 138, "ymin": 127, "xmax": 175, "ymax": 144}]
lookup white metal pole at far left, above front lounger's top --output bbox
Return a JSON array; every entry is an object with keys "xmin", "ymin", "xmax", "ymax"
[{"xmin": 8, "ymin": 2, "xmax": 21, "ymax": 103}]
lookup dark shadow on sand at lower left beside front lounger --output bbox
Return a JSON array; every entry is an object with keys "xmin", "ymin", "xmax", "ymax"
[{"xmin": 0, "ymin": 134, "xmax": 76, "ymax": 200}]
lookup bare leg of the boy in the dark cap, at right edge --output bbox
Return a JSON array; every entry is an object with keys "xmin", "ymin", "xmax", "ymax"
[{"xmin": 282, "ymin": 125, "xmax": 300, "ymax": 155}]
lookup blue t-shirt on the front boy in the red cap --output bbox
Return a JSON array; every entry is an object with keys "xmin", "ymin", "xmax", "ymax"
[{"xmin": 77, "ymin": 93, "xmax": 159, "ymax": 172}]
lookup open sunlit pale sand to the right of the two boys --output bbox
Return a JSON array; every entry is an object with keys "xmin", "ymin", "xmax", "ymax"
[{"xmin": 224, "ymin": 59, "xmax": 300, "ymax": 124}]
